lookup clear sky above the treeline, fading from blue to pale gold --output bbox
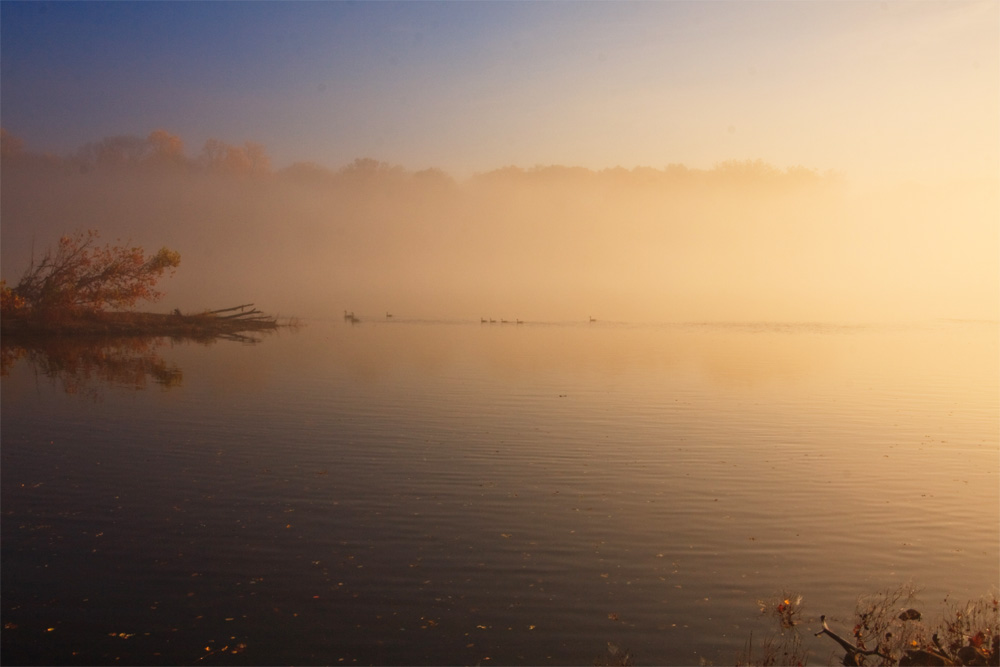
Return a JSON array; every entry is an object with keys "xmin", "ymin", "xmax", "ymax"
[{"xmin": 0, "ymin": 0, "xmax": 1000, "ymax": 179}]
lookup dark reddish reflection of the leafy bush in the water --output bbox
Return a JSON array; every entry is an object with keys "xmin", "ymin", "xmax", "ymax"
[{"xmin": 0, "ymin": 337, "xmax": 184, "ymax": 394}]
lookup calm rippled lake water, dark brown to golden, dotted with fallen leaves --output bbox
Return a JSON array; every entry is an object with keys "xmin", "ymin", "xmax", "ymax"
[{"xmin": 2, "ymin": 318, "xmax": 1000, "ymax": 664}]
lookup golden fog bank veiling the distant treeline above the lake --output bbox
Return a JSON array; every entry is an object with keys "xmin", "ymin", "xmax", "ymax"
[{"xmin": 0, "ymin": 131, "xmax": 1000, "ymax": 321}]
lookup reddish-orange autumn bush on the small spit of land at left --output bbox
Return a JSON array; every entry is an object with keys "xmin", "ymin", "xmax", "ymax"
[{"xmin": 2, "ymin": 230, "xmax": 180, "ymax": 316}]
